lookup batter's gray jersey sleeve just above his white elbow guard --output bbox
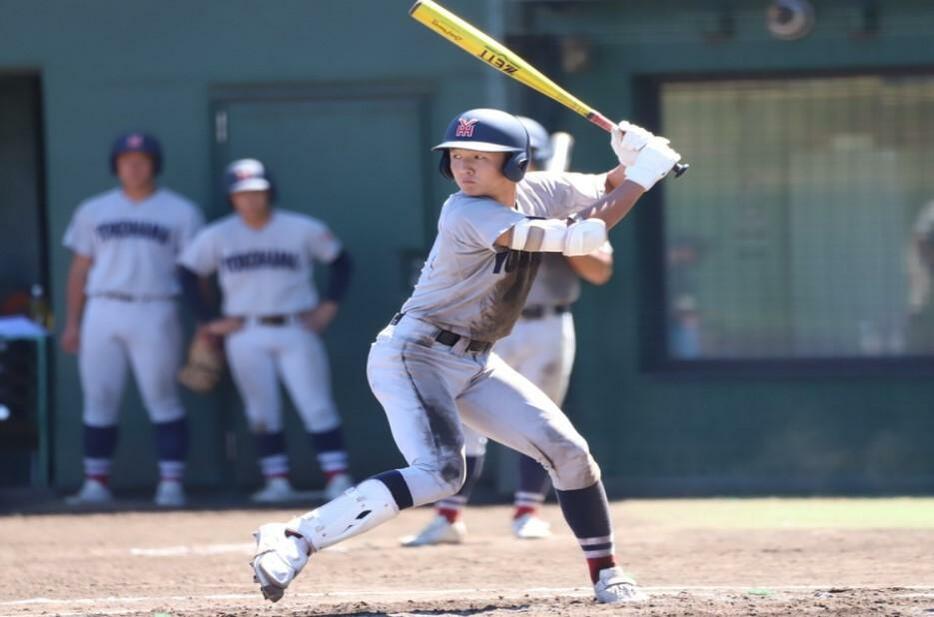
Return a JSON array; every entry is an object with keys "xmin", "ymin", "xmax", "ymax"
[{"xmin": 439, "ymin": 198, "xmax": 525, "ymax": 251}]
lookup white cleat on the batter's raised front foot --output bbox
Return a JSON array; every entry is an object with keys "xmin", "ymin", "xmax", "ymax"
[{"xmin": 250, "ymin": 523, "xmax": 308, "ymax": 602}]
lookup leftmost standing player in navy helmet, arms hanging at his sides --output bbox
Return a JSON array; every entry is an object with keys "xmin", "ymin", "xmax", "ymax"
[{"xmin": 61, "ymin": 133, "xmax": 202, "ymax": 506}]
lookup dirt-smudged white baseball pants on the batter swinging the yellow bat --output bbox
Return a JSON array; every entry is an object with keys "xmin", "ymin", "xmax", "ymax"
[{"xmin": 367, "ymin": 316, "xmax": 600, "ymax": 506}]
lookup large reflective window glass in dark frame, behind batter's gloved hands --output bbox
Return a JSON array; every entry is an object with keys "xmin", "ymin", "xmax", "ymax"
[{"xmin": 658, "ymin": 75, "xmax": 934, "ymax": 361}]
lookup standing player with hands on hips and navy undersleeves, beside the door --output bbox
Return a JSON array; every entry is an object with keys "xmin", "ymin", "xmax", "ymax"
[{"xmin": 179, "ymin": 159, "xmax": 351, "ymax": 503}]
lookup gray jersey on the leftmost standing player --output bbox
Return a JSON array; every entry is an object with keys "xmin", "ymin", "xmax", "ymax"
[{"xmin": 63, "ymin": 188, "xmax": 203, "ymax": 297}]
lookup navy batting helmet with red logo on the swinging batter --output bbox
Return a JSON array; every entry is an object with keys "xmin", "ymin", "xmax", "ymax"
[{"xmin": 432, "ymin": 109, "xmax": 529, "ymax": 182}]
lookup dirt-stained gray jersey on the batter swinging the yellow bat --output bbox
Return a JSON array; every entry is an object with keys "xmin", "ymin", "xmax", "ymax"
[{"xmin": 402, "ymin": 172, "xmax": 606, "ymax": 342}]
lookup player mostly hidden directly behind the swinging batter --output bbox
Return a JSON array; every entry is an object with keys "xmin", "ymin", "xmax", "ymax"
[{"xmin": 402, "ymin": 116, "xmax": 613, "ymax": 547}]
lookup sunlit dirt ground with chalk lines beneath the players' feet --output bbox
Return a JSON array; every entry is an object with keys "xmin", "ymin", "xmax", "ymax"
[{"xmin": 0, "ymin": 499, "xmax": 934, "ymax": 617}]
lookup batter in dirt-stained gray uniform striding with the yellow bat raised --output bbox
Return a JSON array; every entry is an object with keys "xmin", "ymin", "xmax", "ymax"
[{"xmin": 252, "ymin": 109, "xmax": 680, "ymax": 603}]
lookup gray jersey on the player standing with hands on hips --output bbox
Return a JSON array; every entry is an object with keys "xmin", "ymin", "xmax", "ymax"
[{"xmin": 179, "ymin": 210, "xmax": 342, "ymax": 316}]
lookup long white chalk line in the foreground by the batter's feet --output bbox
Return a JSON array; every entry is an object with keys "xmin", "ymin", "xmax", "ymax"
[{"xmin": 0, "ymin": 584, "xmax": 934, "ymax": 617}]
